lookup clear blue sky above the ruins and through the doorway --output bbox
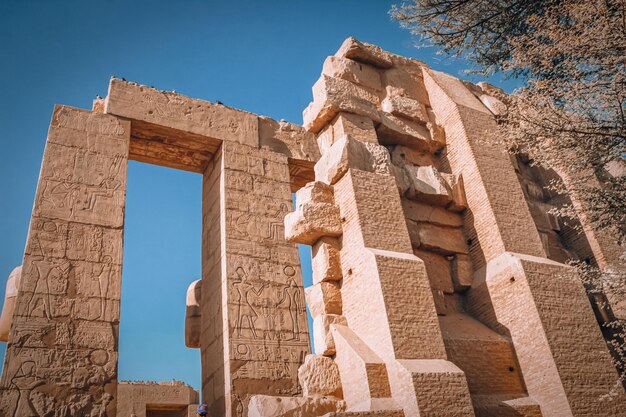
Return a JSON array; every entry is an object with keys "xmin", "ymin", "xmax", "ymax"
[{"xmin": 0, "ymin": 0, "xmax": 514, "ymax": 388}]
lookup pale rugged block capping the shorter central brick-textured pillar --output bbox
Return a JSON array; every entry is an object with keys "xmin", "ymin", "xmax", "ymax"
[{"xmin": 315, "ymin": 136, "xmax": 391, "ymax": 184}]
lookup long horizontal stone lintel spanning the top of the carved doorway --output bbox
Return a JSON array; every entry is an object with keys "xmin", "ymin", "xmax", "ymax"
[{"xmin": 101, "ymin": 78, "xmax": 320, "ymax": 191}]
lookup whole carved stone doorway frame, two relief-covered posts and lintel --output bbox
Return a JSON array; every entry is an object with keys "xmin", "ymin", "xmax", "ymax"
[{"xmin": 0, "ymin": 83, "xmax": 314, "ymax": 417}]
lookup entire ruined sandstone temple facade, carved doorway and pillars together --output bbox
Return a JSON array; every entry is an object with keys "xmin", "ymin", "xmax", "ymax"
[{"xmin": 0, "ymin": 38, "xmax": 626, "ymax": 417}]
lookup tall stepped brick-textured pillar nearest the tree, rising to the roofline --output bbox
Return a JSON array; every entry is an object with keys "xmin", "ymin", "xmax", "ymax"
[{"xmin": 424, "ymin": 66, "xmax": 626, "ymax": 417}]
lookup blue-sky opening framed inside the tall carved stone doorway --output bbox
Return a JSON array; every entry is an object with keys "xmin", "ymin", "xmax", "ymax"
[{"xmin": 118, "ymin": 161, "xmax": 202, "ymax": 389}]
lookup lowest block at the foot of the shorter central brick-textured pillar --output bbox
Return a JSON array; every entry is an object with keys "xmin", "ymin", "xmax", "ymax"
[{"xmin": 387, "ymin": 359, "xmax": 474, "ymax": 417}]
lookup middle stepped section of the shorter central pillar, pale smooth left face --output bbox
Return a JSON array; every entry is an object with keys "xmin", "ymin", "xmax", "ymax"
[{"xmin": 341, "ymin": 248, "xmax": 445, "ymax": 360}]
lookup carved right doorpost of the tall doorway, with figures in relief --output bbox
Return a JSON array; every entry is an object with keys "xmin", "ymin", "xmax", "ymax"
[{"xmin": 200, "ymin": 142, "xmax": 310, "ymax": 417}]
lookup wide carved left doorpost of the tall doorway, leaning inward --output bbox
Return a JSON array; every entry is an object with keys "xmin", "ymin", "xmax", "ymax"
[{"xmin": 0, "ymin": 106, "xmax": 130, "ymax": 417}]
